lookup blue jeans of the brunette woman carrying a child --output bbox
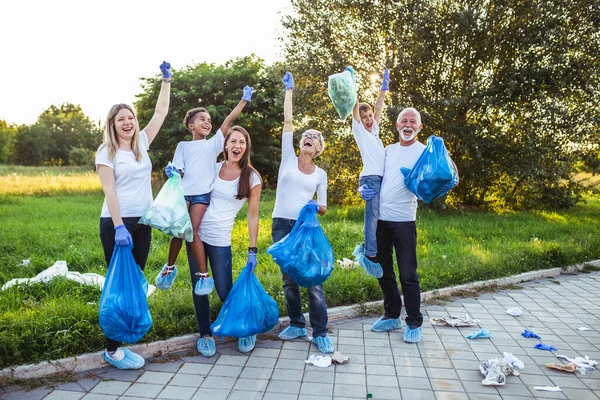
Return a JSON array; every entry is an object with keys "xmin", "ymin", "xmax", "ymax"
[{"xmin": 185, "ymin": 242, "xmax": 233, "ymax": 336}]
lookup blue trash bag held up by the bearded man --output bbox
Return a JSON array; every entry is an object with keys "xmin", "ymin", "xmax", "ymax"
[{"xmin": 400, "ymin": 135, "xmax": 458, "ymax": 203}]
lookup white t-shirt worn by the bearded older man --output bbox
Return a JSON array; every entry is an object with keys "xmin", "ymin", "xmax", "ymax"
[{"xmin": 379, "ymin": 142, "xmax": 425, "ymax": 222}]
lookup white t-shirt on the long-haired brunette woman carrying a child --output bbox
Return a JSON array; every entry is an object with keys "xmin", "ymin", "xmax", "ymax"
[{"xmin": 198, "ymin": 163, "xmax": 260, "ymax": 247}]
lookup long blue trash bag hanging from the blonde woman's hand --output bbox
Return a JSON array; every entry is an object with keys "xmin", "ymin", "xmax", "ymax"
[{"xmin": 99, "ymin": 246, "xmax": 152, "ymax": 343}]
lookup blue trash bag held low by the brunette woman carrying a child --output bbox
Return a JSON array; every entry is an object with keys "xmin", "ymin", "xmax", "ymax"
[{"xmin": 210, "ymin": 265, "xmax": 279, "ymax": 338}]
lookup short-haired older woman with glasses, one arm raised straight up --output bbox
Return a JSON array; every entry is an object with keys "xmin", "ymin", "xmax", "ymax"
[{"xmin": 271, "ymin": 72, "xmax": 334, "ymax": 353}]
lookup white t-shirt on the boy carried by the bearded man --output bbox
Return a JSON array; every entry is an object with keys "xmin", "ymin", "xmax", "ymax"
[{"xmin": 352, "ymin": 118, "xmax": 385, "ymax": 176}]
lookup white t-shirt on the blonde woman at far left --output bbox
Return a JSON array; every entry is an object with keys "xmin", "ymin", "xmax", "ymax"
[{"xmin": 96, "ymin": 131, "xmax": 152, "ymax": 217}]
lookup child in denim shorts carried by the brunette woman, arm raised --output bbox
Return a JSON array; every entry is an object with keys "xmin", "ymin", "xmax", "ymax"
[{"xmin": 156, "ymin": 86, "xmax": 252, "ymax": 292}]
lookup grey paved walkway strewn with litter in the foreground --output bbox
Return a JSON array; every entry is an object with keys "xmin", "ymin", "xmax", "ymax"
[{"xmin": 0, "ymin": 272, "xmax": 600, "ymax": 400}]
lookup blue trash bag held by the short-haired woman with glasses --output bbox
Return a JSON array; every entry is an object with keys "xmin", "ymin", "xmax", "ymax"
[{"xmin": 267, "ymin": 205, "xmax": 334, "ymax": 287}]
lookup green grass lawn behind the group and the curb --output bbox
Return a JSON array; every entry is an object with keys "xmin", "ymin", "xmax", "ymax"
[{"xmin": 0, "ymin": 167, "xmax": 600, "ymax": 368}]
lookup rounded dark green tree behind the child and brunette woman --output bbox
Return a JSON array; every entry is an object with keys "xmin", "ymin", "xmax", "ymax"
[{"xmin": 135, "ymin": 55, "xmax": 283, "ymax": 186}]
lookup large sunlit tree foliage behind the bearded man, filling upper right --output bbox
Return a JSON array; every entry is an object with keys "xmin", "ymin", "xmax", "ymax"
[{"xmin": 283, "ymin": 0, "xmax": 600, "ymax": 208}]
